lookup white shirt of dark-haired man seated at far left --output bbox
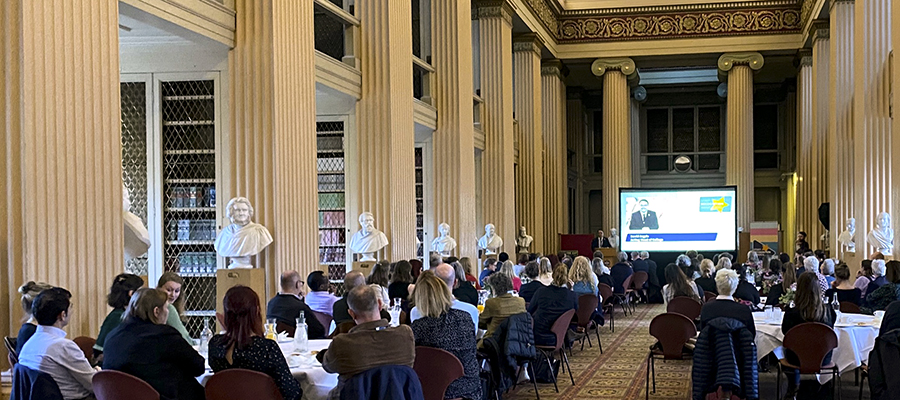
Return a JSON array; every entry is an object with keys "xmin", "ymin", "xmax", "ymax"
[{"xmin": 19, "ymin": 325, "xmax": 96, "ymax": 400}]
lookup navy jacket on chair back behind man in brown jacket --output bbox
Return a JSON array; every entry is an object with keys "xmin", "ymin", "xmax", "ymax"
[{"xmin": 340, "ymin": 365, "xmax": 425, "ymax": 400}]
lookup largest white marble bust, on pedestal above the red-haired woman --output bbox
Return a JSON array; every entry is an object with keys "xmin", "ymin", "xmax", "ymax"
[{"xmin": 215, "ymin": 197, "xmax": 272, "ymax": 268}]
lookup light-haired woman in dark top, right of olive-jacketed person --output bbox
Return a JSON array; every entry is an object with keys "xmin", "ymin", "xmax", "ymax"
[{"xmin": 528, "ymin": 264, "xmax": 578, "ymax": 346}]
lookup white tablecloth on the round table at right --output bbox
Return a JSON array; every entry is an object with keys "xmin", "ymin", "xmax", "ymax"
[{"xmin": 753, "ymin": 312, "xmax": 880, "ymax": 383}]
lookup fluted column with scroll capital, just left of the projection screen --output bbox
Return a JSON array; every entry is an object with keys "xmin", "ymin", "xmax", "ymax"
[{"xmin": 591, "ymin": 58, "xmax": 637, "ymax": 234}]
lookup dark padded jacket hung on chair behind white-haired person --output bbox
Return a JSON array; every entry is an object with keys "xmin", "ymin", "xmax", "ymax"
[{"xmin": 691, "ymin": 317, "xmax": 759, "ymax": 400}]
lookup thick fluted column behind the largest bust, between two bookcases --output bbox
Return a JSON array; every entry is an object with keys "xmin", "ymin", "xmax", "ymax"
[{"xmin": 226, "ymin": 0, "xmax": 319, "ymax": 295}]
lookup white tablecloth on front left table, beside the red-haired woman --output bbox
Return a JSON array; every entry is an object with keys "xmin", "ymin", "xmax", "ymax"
[{"xmin": 197, "ymin": 339, "xmax": 338, "ymax": 400}]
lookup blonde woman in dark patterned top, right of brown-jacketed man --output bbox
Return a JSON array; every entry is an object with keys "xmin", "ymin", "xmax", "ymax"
[{"xmin": 411, "ymin": 271, "xmax": 481, "ymax": 400}]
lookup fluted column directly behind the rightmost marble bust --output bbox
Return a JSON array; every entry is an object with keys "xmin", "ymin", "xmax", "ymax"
[{"xmin": 853, "ymin": 0, "xmax": 896, "ymax": 254}]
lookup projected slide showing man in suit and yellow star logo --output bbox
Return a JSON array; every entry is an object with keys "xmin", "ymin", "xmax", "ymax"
[{"xmin": 619, "ymin": 187, "xmax": 737, "ymax": 251}]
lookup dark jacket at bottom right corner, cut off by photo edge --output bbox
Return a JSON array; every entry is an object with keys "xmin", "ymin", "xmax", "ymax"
[{"xmin": 869, "ymin": 329, "xmax": 900, "ymax": 400}]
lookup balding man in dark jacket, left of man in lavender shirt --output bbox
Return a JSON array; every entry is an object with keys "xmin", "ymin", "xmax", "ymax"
[{"xmin": 266, "ymin": 271, "xmax": 329, "ymax": 339}]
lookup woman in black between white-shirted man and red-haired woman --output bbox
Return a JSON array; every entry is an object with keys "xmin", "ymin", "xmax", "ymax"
[{"xmin": 103, "ymin": 288, "xmax": 206, "ymax": 400}]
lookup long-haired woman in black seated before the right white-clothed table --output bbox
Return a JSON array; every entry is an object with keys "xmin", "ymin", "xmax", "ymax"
[{"xmin": 781, "ymin": 271, "xmax": 835, "ymax": 399}]
